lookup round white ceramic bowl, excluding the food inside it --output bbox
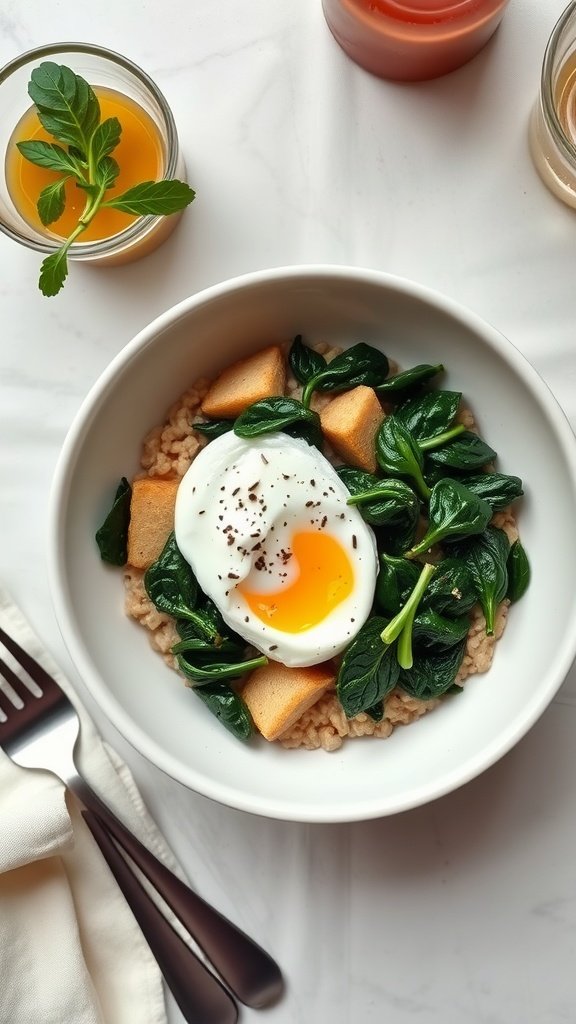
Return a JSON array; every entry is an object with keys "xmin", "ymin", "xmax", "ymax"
[{"xmin": 50, "ymin": 266, "xmax": 576, "ymax": 822}]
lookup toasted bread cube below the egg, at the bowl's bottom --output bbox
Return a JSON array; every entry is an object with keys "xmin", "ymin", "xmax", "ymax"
[{"xmin": 241, "ymin": 662, "xmax": 336, "ymax": 740}]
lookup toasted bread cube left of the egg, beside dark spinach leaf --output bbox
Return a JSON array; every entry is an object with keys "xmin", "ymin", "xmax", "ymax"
[{"xmin": 128, "ymin": 476, "xmax": 180, "ymax": 569}]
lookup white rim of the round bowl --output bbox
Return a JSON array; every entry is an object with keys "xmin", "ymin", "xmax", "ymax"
[{"xmin": 47, "ymin": 263, "xmax": 576, "ymax": 823}]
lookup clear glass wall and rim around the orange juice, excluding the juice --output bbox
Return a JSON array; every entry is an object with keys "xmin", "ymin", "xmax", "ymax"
[{"xmin": 0, "ymin": 42, "xmax": 186, "ymax": 266}]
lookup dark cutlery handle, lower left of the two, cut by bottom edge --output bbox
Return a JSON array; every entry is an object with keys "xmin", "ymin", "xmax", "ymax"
[{"xmin": 82, "ymin": 811, "xmax": 238, "ymax": 1024}]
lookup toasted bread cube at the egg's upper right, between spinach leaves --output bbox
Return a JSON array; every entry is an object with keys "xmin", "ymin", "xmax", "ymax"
[{"xmin": 320, "ymin": 384, "xmax": 384, "ymax": 473}]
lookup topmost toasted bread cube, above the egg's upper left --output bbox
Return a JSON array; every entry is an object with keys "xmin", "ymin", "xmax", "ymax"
[{"xmin": 202, "ymin": 345, "xmax": 286, "ymax": 420}]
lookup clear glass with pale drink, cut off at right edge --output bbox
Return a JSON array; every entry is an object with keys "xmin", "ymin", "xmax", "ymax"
[{"xmin": 529, "ymin": 3, "xmax": 576, "ymax": 208}]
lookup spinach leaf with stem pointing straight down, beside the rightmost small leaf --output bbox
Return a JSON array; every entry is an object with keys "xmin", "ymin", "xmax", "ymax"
[{"xmin": 454, "ymin": 526, "xmax": 509, "ymax": 636}]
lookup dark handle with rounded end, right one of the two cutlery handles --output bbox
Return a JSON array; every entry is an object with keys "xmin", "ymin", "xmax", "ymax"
[{"xmin": 74, "ymin": 779, "xmax": 284, "ymax": 1009}]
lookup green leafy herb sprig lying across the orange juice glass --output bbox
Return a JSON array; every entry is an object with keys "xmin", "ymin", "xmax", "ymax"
[{"xmin": 16, "ymin": 60, "xmax": 196, "ymax": 296}]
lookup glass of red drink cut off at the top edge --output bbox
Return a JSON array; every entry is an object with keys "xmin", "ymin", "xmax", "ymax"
[{"xmin": 322, "ymin": 0, "xmax": 509, "ymax": 81}]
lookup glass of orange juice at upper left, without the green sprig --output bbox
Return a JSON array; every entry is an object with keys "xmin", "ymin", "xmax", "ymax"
[{"xmin": 0, "ymin": 42, "xmax": 186, "ymax": 266}]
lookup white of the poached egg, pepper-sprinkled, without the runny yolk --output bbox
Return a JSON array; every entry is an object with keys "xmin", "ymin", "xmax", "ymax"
[{"xmin": 174, "ymin": 431, "xmax": 378, "ymax": 668}]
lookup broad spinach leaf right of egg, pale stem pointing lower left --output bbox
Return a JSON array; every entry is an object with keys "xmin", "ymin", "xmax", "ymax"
[{"xmin": 406, "ymin": 478, "xmax": 492, "ymax": 558}]
